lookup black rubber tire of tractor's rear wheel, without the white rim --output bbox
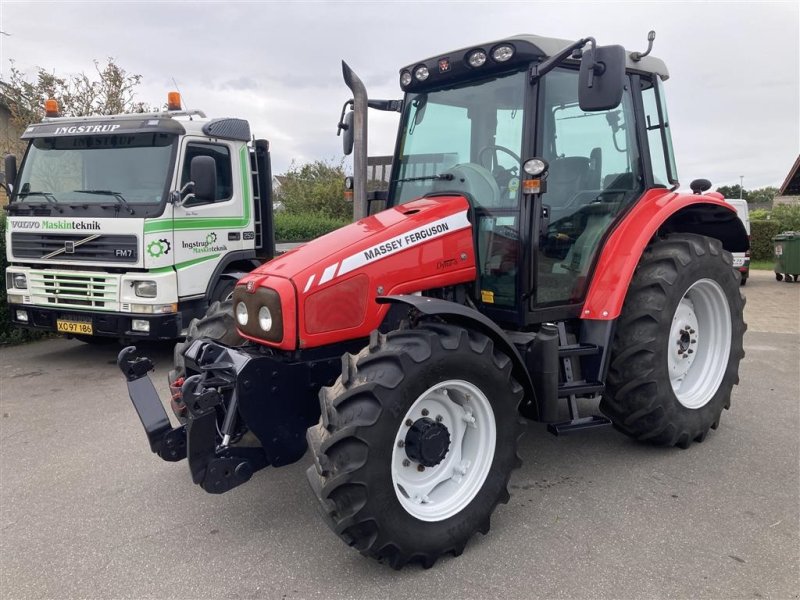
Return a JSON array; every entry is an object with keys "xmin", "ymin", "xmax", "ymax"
[{"xmin": 600, "ymin": 234, "xmax": 747, "ymax": 448}]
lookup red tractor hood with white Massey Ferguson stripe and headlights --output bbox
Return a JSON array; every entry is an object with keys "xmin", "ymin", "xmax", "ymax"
[{"xmin": 234, "ymin": 195, "xmax": 476, "ymax": 350}]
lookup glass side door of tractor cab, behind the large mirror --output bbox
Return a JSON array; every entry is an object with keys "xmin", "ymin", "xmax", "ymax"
[{"xmin": 535, "ymin": 69, "xmax": 644, "ymax": 306}]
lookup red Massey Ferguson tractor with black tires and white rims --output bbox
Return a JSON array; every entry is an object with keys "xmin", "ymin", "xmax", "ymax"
[{"xmin": 119, "ymin": 34, "xmax": 747, "ymax": 568}]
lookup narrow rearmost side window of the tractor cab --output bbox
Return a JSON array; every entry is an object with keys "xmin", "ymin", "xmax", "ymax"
[{"xmin": 641, "ymin": 77, "xmax": 678, "ymax": 187}]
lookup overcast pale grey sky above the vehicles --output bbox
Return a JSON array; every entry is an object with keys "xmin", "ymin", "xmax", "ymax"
[{"xmin": 0, "ymin": 0, "xmax": 800, "ymax": 189}]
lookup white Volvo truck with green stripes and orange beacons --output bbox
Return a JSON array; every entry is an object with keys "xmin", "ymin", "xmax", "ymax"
[{"xmin": 5, "ymin": 93, "xmax": 275, "ymax": 343}]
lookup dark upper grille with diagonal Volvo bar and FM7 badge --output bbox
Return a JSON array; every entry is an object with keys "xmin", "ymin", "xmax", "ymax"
[{"xmin": 11, "ymin": 232, "xmax": 139, "ymax": 263}]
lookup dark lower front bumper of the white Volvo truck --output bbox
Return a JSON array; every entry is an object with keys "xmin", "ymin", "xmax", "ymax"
[{"xmin": 8, "ymin": 304, "xmax": 183, "ymax": 340}]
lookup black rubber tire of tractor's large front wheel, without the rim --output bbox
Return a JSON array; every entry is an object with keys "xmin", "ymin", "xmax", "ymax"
[{"xmin": 307, "ymin": 323, "xmax": 523, "ymax": 569}]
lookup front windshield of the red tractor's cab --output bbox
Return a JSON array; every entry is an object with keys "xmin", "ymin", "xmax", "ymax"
[{"xmin": 392, "ymin": 71, "xmax": 526, "ymax": 208}]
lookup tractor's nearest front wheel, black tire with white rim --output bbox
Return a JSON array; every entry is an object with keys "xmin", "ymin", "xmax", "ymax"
[{"xmin": 307, "ymin": 323, "xmax": 523, "ymax": 569}]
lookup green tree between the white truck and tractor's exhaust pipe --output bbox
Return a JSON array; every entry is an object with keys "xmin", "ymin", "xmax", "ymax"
[{"xmin": 276, "ymin": 159, "xmax": 353, "ymax": 219}]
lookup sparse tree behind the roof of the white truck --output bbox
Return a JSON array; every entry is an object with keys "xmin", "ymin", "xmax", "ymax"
[{"xmin": 0, "ymin": 58, "xmax": 149, "ymax": 154}]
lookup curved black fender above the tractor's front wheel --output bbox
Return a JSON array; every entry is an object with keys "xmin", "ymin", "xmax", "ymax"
[{"xmin": 375, "ymin": 295, "xmax": 539, "ymax": 412}]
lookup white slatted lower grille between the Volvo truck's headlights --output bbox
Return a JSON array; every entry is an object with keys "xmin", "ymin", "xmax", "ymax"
[{"xmin": 28, "ymin": 271, "xmax": 119, "ymax": 310}]
